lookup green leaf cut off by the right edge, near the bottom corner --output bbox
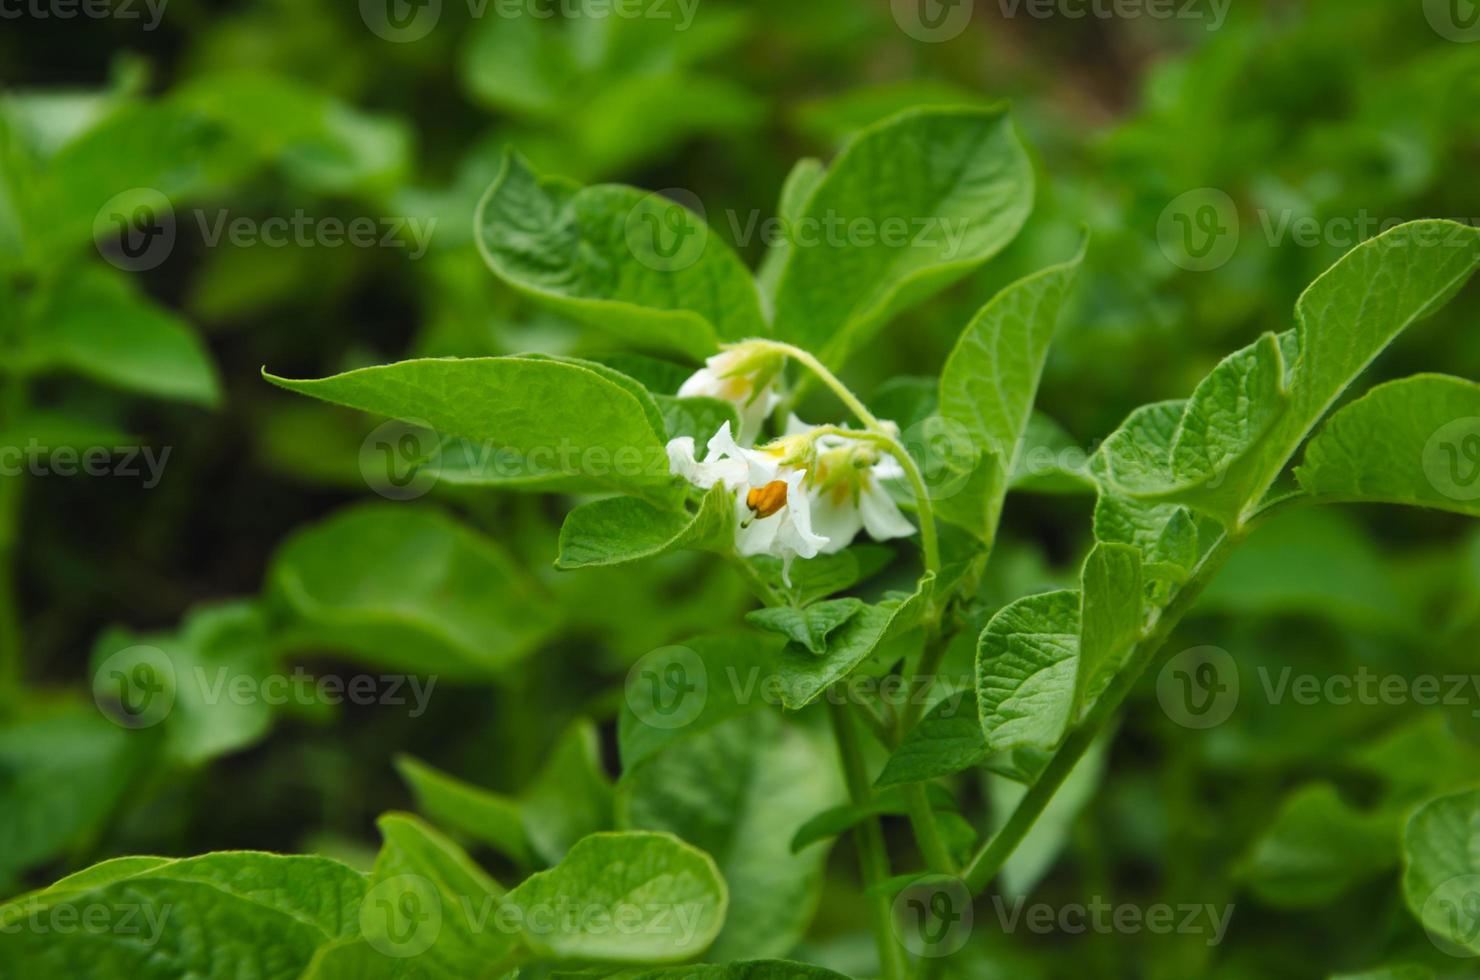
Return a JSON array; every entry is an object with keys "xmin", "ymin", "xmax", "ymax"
[{"xmin": 1403, "ymin": 791, "xmax": 1480, "ymax": 956}]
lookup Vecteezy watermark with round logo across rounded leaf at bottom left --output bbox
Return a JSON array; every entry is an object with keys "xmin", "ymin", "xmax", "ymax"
[{"xmin": 360, "ymin": 875, "xmax": 709, "ymax": 959}]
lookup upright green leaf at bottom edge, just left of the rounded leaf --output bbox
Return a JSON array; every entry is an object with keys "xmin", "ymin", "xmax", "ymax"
[{"xmin": 360, "ymin": 813, "xmax": 521, "ymax": 976}]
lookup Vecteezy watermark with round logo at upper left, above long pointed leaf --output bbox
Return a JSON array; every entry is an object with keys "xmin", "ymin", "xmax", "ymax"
[{"xmin": 93, "ymin": 187, "xmax": 437, "ymax": 272}]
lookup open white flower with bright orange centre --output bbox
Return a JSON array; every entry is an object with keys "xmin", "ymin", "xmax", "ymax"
[{"xmin": 667, "ymin": 422, "xmax": 829, "ymax": 582}]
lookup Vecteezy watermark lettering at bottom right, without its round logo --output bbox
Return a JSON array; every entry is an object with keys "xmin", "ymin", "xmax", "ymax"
[{"xmin": 992, "ymin": 896, "xmax": 1233, "ymax": 946}]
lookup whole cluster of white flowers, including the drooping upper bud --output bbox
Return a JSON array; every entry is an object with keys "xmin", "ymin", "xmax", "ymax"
[{"xmin": 667, "ymin": 346, "xmax": 915, "ymax": 573}]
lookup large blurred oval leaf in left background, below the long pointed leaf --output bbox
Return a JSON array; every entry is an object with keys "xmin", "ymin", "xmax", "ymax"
[{"xmin": 268, "ymin": 503, "xmax": 555, "ymax": 679}]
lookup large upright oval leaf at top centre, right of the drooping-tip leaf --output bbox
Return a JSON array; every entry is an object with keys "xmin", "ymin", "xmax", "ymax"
[{"xmin": 776, "ymin": 108, "xmax": 1033, "ymax": 366}]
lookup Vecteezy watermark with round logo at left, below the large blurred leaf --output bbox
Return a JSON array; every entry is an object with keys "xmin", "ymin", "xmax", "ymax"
[{"xmin": 93, "ymin": 644, "xmax": 437, "ymax": 728}]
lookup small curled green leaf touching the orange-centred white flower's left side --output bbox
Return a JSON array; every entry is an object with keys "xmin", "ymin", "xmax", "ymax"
[{"xmin": 555, "ymin": 484, "xmax": 736, "ymax": 570}]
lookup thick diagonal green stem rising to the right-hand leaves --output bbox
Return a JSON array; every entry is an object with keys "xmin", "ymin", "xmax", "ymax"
[{"xmin": 962, "ymin": 526, "xmax": 1249, "ymax": 894}]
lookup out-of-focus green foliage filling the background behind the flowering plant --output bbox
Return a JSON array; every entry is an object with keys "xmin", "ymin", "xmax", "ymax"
[{"xmin": 0, "ymin": 0, "xmax": 1480, "ymax": 977}]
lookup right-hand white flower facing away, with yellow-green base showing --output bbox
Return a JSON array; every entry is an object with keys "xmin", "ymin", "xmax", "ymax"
[{"xmin": 786, "ymin": 415, "xmax": 915, "ymax": 555}]
